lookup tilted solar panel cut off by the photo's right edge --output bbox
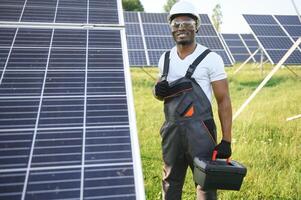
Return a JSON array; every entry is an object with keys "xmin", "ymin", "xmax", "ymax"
[{"xmin": 243, "ymin": 15, "xmax": 301, "ymax": 64}]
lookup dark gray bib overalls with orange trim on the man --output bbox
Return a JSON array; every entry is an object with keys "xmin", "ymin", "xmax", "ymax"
[{"xmin": 160, "ymin": 49, "xmax": 216, "ymax": 200}]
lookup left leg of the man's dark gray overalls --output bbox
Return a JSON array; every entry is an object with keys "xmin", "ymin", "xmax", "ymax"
[{"xmin": 161, "ymin": 122, "xmax": 188, "ymax": 200}]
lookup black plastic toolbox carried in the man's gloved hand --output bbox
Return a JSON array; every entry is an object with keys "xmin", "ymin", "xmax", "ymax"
[{"xmin": 193, "ymin": 158, "xmax": 247, "ymax": 190}]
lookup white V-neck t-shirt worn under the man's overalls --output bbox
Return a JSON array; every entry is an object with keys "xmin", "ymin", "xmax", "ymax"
[{"xmin": 158, "ymin": 44, "xmax": 227, "ymax": 102}]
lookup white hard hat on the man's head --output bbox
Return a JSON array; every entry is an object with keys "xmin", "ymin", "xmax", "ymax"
[{"xmin": 167, "ymin": 0, "xmax": 201, "ymax": 29}]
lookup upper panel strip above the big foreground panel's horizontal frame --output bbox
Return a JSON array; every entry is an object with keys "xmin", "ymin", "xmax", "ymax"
[{"xmin": 0, "ymin": 0, "xmax": 119, "ymax": 24}]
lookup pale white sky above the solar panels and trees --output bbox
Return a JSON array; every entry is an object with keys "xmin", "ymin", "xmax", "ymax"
[{"xmin": 140, "ymin": 0, "xmax": 301, "ymax": 33}]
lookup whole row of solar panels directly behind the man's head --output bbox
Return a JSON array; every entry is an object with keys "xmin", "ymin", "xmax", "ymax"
[{"xmin": 124, "ymin": 12, "xmax": 232, "ymax": 66}]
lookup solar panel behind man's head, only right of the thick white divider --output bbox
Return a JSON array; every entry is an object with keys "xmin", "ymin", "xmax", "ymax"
[{"xmin": 140, "ymin": 13, "xmax": 232, "ymax": 66}]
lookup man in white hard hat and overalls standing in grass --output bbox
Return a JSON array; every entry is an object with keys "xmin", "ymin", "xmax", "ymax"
[{"xmin": 154, "ymin": 1, "xmax": 232, "ymax": 200}]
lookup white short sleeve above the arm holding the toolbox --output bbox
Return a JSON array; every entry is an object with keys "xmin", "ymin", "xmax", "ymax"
[{"xmin": 208, "ymin": 53, "xmax": 227, "ymax": 82}]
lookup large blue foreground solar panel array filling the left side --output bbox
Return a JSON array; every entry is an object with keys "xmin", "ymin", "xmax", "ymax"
[{"xmin": 0, "ymin": 0, "xmax": 145, "ymax": 200}]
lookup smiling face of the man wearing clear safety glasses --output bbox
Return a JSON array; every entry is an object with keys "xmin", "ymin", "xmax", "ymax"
[{"xmin": 170, "ymin": 16, "xmax": 196, "ymax": 45}]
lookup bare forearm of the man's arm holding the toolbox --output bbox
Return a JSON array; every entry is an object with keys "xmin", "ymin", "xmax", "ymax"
[{"xmin": 218, "ymin": 95, "xmax": 232, "ymax": 142}]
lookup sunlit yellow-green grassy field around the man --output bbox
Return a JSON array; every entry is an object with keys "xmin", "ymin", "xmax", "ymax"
[{"xmin": 131, "ymin": 64, "xmax": 301, "ymax": 200}]
